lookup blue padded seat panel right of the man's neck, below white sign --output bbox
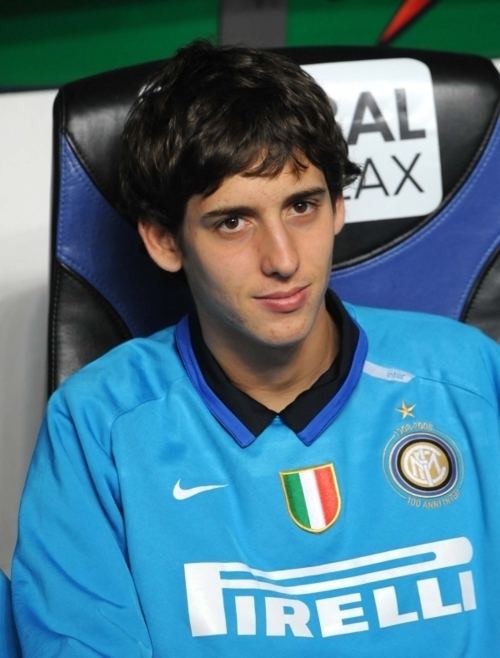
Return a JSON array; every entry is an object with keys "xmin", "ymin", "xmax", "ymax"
[{"xmin": 331, "ymin": 122, "xmax": 500, "ymax": 319}]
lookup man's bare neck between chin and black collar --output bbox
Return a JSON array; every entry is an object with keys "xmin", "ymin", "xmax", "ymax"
[{"xmin": 204, "ymin": 308, "xmax": 339, "ymax": 412}]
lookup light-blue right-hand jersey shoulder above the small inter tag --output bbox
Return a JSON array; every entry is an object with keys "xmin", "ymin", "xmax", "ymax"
[{"xmin": 346, "ymin": 304, "xmax": 500, "ymax": 404}]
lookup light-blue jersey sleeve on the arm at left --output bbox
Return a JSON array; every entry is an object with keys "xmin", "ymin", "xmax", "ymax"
[{"xmin": 12, "ymin": 386, "xmax": 153, "ymax": 658}]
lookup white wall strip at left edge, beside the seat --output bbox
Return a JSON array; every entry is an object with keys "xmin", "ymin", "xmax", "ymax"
[{"xmin": 0, "ymin": 91, "xmax": 55, "ymax": 573}]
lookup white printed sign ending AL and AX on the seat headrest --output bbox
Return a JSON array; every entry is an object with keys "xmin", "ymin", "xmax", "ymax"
[{"xmin": 303, "ymin": 58, "xmax": 443, "ymax": 222}]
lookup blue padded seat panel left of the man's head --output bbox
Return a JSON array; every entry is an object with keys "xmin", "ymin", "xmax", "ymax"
[{"xmin": 56, "ymin": 137, "xmax": 191, "ymax": 336}]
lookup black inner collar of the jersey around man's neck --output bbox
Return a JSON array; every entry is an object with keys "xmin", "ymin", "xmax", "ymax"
[{"xmin": 189, "ymin": 291, "xmax": 360, "ymax": 436}]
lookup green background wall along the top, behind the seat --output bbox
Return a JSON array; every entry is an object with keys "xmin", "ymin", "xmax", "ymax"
[{"xmin": 0, "ymin": 0, "xmax": 500, "ymax": 88}]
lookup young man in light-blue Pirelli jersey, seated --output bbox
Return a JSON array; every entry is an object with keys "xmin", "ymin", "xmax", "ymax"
[{"xmin": 13, "ymin": 44, "xmax": 500, "ymax": 658}]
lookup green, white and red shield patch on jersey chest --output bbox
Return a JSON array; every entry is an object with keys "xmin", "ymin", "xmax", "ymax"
[{"xmin": 280, "ymin": 464, "xmax": 340, "ymax": 532}]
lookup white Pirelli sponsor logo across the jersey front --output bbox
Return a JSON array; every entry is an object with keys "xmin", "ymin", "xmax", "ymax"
[{"xmin": 184, "ymin": 537, "xmax": 477, "ymax": 638}]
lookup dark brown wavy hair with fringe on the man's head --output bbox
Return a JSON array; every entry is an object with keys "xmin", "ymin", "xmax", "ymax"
[{"xmin": 120, "ymin": 41, "xmax": 359, "ymax": 235}]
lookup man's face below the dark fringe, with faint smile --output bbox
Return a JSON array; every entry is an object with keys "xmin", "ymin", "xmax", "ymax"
[{"xmin": 143, "ymin": 158, "xmax": 343, "ymax": 349}]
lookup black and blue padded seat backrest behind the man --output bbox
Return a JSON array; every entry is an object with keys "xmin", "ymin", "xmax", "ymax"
[{"xmin": 49, "ymin": 47, "xmax": 500, "ymax": 389}]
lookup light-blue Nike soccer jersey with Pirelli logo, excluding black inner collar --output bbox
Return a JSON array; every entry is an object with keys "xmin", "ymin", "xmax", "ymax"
[{"xmin": 13, "ymin": 300, "xmax": 500, "ymax": 658}]
